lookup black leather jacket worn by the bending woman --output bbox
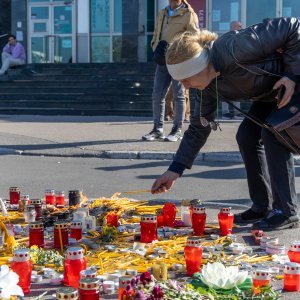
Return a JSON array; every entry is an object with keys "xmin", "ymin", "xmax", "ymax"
[{"xmin": 169, "ymin": 18, "xmax": 300, "ymax": 174}]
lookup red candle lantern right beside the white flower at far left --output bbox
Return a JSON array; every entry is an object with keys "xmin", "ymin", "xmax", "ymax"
[{"xmin": 10, "ymin": 249, "xmax": 32, "ymax": 295}]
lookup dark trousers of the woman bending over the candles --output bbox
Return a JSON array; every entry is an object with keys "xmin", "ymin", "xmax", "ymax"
[{"xmin": 236, "ymin": 102, "xmax": 297, "ymax": 216}]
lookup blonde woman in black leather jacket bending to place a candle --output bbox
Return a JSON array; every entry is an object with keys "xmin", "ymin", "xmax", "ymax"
[{"xmin": 152, "ymin": 18, "xmax": 300, "ymax": 230}]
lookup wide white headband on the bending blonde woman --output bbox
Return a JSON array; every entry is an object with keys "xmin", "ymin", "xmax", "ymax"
[{"xmin": 167, "ymin": 50, "xmax": 209, "ymax": 81}]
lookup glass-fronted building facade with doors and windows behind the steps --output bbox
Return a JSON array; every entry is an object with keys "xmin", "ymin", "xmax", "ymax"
[{"xmin": 0, "ymin": 0, "xmax": 300, "ymax": 63}]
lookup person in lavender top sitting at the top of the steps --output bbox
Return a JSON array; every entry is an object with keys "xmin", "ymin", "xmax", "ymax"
[{"xmin": 0, "ymin": 35, "xmax": 26, "ymax": 75}]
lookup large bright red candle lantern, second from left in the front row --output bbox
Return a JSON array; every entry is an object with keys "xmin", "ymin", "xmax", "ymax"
[{"xmin": 63, "ymin": 247, "xmax": 86, "ymax": 288}]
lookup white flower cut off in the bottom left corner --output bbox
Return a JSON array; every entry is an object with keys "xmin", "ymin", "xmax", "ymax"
[{"xmin": 0, "ymin": 265, "xmax": 24, "ymax": 299}]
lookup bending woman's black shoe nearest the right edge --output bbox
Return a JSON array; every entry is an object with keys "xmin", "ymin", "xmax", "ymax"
[{"xmin": 252, "ymin": 213, "xmax": 300, "ymax": 231}]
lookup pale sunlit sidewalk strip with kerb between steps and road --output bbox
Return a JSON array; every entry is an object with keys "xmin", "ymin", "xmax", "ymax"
[{"xmin": 0, "ymin": 115, "xmax": 298, "ymax": 163}]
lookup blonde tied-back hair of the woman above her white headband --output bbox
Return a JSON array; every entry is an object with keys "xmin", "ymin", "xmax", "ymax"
[{"xmin": 166, "ymin": 30, "xmax": 218, "ymax": 65}]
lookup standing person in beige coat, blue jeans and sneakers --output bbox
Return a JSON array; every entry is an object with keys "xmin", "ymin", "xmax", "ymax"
[{"xmin": 142, "ymin": 0, "xmax": 199, "ymax": 142}]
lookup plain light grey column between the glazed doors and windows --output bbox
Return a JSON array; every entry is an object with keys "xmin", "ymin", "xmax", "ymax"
[{"xmin": 76, "ymin": 0, "xmax": 90, "ymax": 63}]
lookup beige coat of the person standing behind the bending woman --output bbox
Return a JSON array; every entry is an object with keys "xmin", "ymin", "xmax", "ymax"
[{"xmin": 151, "ymin": 1, "xmax": 199, "ymax": 50}]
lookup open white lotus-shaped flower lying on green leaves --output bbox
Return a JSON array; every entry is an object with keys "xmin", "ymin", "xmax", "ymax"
[{"xmin": 200, "ymin": 262, "xmax": 248, "ymax": 290}]
